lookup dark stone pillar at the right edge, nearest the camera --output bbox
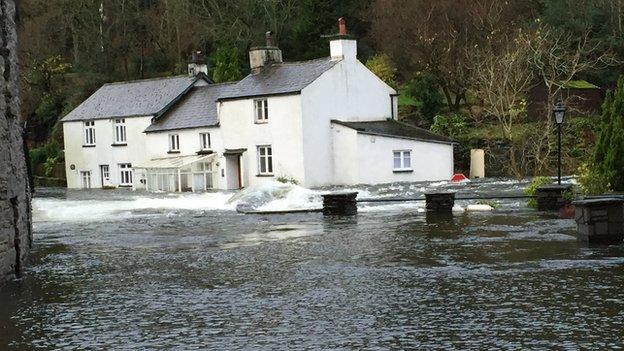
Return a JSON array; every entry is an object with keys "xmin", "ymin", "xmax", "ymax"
[{"xmin": 573, "ymin": 198, "xmax": 624, "ymax": 244}]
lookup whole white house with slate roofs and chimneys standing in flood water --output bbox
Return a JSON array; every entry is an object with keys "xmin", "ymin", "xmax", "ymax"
[{"xmin": 62, "ymin": 20, "xmax": 454, "ymax": 191}]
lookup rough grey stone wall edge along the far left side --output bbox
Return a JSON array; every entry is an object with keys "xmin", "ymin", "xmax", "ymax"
[{"xmin": 0, "ymin": 0, "xmax": 32, "ymax": 283}]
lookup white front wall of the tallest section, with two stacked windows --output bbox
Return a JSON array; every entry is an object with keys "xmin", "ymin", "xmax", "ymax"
[{"xmin": 218, "ymin": 95, "xmax": 305, "ymax": 186}]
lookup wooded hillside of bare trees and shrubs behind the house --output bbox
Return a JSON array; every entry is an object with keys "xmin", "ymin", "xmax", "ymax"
[{"xmin": 19, "ymin": 0, "xmax": 624, "ymax": 182}]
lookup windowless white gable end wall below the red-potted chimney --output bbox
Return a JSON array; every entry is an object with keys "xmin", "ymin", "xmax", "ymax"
[{"xmin": 301, "ymin": 60, "xmax": 396, "ymax": 186}]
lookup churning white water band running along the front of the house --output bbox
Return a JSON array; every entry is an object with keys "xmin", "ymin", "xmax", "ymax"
[{"xmin": 33, "ymin": 179, "xmax": 544, "ymax": 221}]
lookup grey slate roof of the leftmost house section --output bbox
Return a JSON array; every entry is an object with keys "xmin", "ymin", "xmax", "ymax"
[{"xmin": 61, "ymin": 76, "xmax": 204, "ymax": 122}]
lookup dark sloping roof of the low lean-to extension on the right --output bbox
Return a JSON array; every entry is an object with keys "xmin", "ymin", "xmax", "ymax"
[{"xmin": 332, "ymin": 120, "xmax": 456, "ymax": 144}]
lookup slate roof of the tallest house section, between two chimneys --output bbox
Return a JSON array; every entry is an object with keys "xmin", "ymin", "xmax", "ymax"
[{"xmin": 219, "ymin": 57, "xmax": 340, "ymax": 100}]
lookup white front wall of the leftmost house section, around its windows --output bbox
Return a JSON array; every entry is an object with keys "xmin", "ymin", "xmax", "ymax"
[{"xmin": 63, "ymin": 116, "xmax": 151, "ymax": 188}]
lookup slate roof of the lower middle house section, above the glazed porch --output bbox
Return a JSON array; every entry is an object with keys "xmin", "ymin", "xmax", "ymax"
[{"xmin": 145, "ymin": 83, "xmax": 236, "ymax": 132}]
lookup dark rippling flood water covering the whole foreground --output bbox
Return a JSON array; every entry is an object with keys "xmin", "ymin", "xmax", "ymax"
[{"xmin": 0, "ymin": 181, "xmax": 624, "ymax": 350}]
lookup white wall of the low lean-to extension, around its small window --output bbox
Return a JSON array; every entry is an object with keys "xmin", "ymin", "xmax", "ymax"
[{"xmin": 357, "ymin": 133, "xmax": 453, "ymax": 184}]
